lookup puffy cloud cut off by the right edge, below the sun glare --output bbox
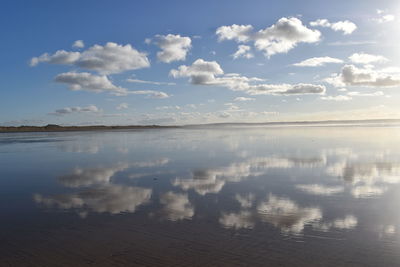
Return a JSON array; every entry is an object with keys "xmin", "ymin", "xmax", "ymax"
[{"xmin": 325, "ymin": 65, "xmax": 400, "ymax": 87}]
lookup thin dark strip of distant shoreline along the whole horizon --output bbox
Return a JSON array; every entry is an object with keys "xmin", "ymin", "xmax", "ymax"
[{"xmin": 0, "ymin": 119, "xmax": 400, "ymax": 133}]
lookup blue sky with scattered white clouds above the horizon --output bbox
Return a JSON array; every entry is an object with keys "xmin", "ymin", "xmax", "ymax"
[{"xmin": 0, "ymin": 0, "xmax": 400, "ymax": 126}]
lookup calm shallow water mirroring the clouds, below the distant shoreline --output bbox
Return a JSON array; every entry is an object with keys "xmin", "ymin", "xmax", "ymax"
[{"xmin": 0, "ymin": 127, "xmax": 400, "ymax": 266}]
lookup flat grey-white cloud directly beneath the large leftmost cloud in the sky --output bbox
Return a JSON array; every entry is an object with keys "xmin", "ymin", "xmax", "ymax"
[{"xmin": 55, "ymin": 72, "xmax": 128, "ymax": 95}]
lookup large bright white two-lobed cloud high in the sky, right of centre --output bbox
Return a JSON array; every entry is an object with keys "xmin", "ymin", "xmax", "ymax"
[{"xmin": 216, "ymin": 17, "xmax": 321, "ymax": 57}]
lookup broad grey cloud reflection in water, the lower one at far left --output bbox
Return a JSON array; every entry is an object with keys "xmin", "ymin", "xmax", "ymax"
[{"xmin": 34, "ymin": 185, "xmax": 152, "ymax": 218}]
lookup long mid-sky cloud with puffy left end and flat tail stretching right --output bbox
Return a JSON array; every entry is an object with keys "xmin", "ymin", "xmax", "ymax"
[{"xmin": 170, "ymin": 59, "xmax": 326, "ymax": 95}]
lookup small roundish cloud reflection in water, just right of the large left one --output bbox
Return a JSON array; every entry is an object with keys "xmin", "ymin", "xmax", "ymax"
[{"xmin": 160, "ymin": 192, "xmax": 194, "ymax": 221}]
